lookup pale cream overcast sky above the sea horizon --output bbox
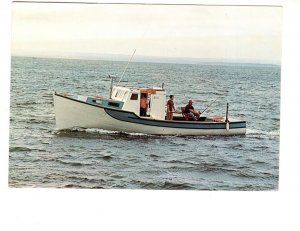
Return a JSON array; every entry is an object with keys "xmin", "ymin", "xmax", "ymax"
[{"xmin": 12, "ymin": 3, "xmax": 282, "ymax": 64}]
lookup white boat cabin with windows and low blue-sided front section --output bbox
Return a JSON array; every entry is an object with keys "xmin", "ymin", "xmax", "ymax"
[{"xmin": 86, "ymin": 86, "xmax": 166, "ymax": 120}]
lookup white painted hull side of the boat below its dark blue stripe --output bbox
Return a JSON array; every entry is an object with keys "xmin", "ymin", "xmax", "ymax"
[{"xmin": 53, "ymin": 93, "xmax": 246, "ymax": 136}]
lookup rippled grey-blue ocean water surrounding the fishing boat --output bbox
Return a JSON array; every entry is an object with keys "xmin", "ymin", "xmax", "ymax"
[{"xmin": 9, "ymin": 57, "xmax": 281, "ymax": 191}]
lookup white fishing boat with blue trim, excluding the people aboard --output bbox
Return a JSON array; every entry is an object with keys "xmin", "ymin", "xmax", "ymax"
[{"xmin": 53, "ymin": 85, "xmax": 246, "ymax": 136}]
